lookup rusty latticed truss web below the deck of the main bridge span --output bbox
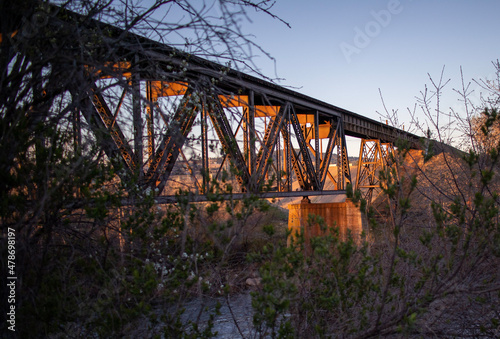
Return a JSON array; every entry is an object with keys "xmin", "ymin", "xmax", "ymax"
[{"xmin": 76, "ymin": 75, "xmax": 351, "ymax": 195}]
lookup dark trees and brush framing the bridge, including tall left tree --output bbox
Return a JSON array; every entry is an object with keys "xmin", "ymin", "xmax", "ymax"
[{"xmin": 0, "ymin": 1, "xmax": 500, "ymax": 338}]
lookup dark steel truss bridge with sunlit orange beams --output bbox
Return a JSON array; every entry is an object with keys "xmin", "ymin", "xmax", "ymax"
[{"xmin": 7, "ymin": 7, "xmax": 419, "ymax": 202}]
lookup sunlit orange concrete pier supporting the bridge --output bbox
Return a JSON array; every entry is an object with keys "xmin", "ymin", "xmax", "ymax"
[{"xmin": 288, "ymin": 197, "xmax": 368, "ymax": 247}]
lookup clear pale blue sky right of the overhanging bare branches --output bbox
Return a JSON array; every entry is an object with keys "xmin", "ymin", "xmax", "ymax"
[{"xmin": 237, "ymin": 0, "xmax": 500, "ymax": 143}]
